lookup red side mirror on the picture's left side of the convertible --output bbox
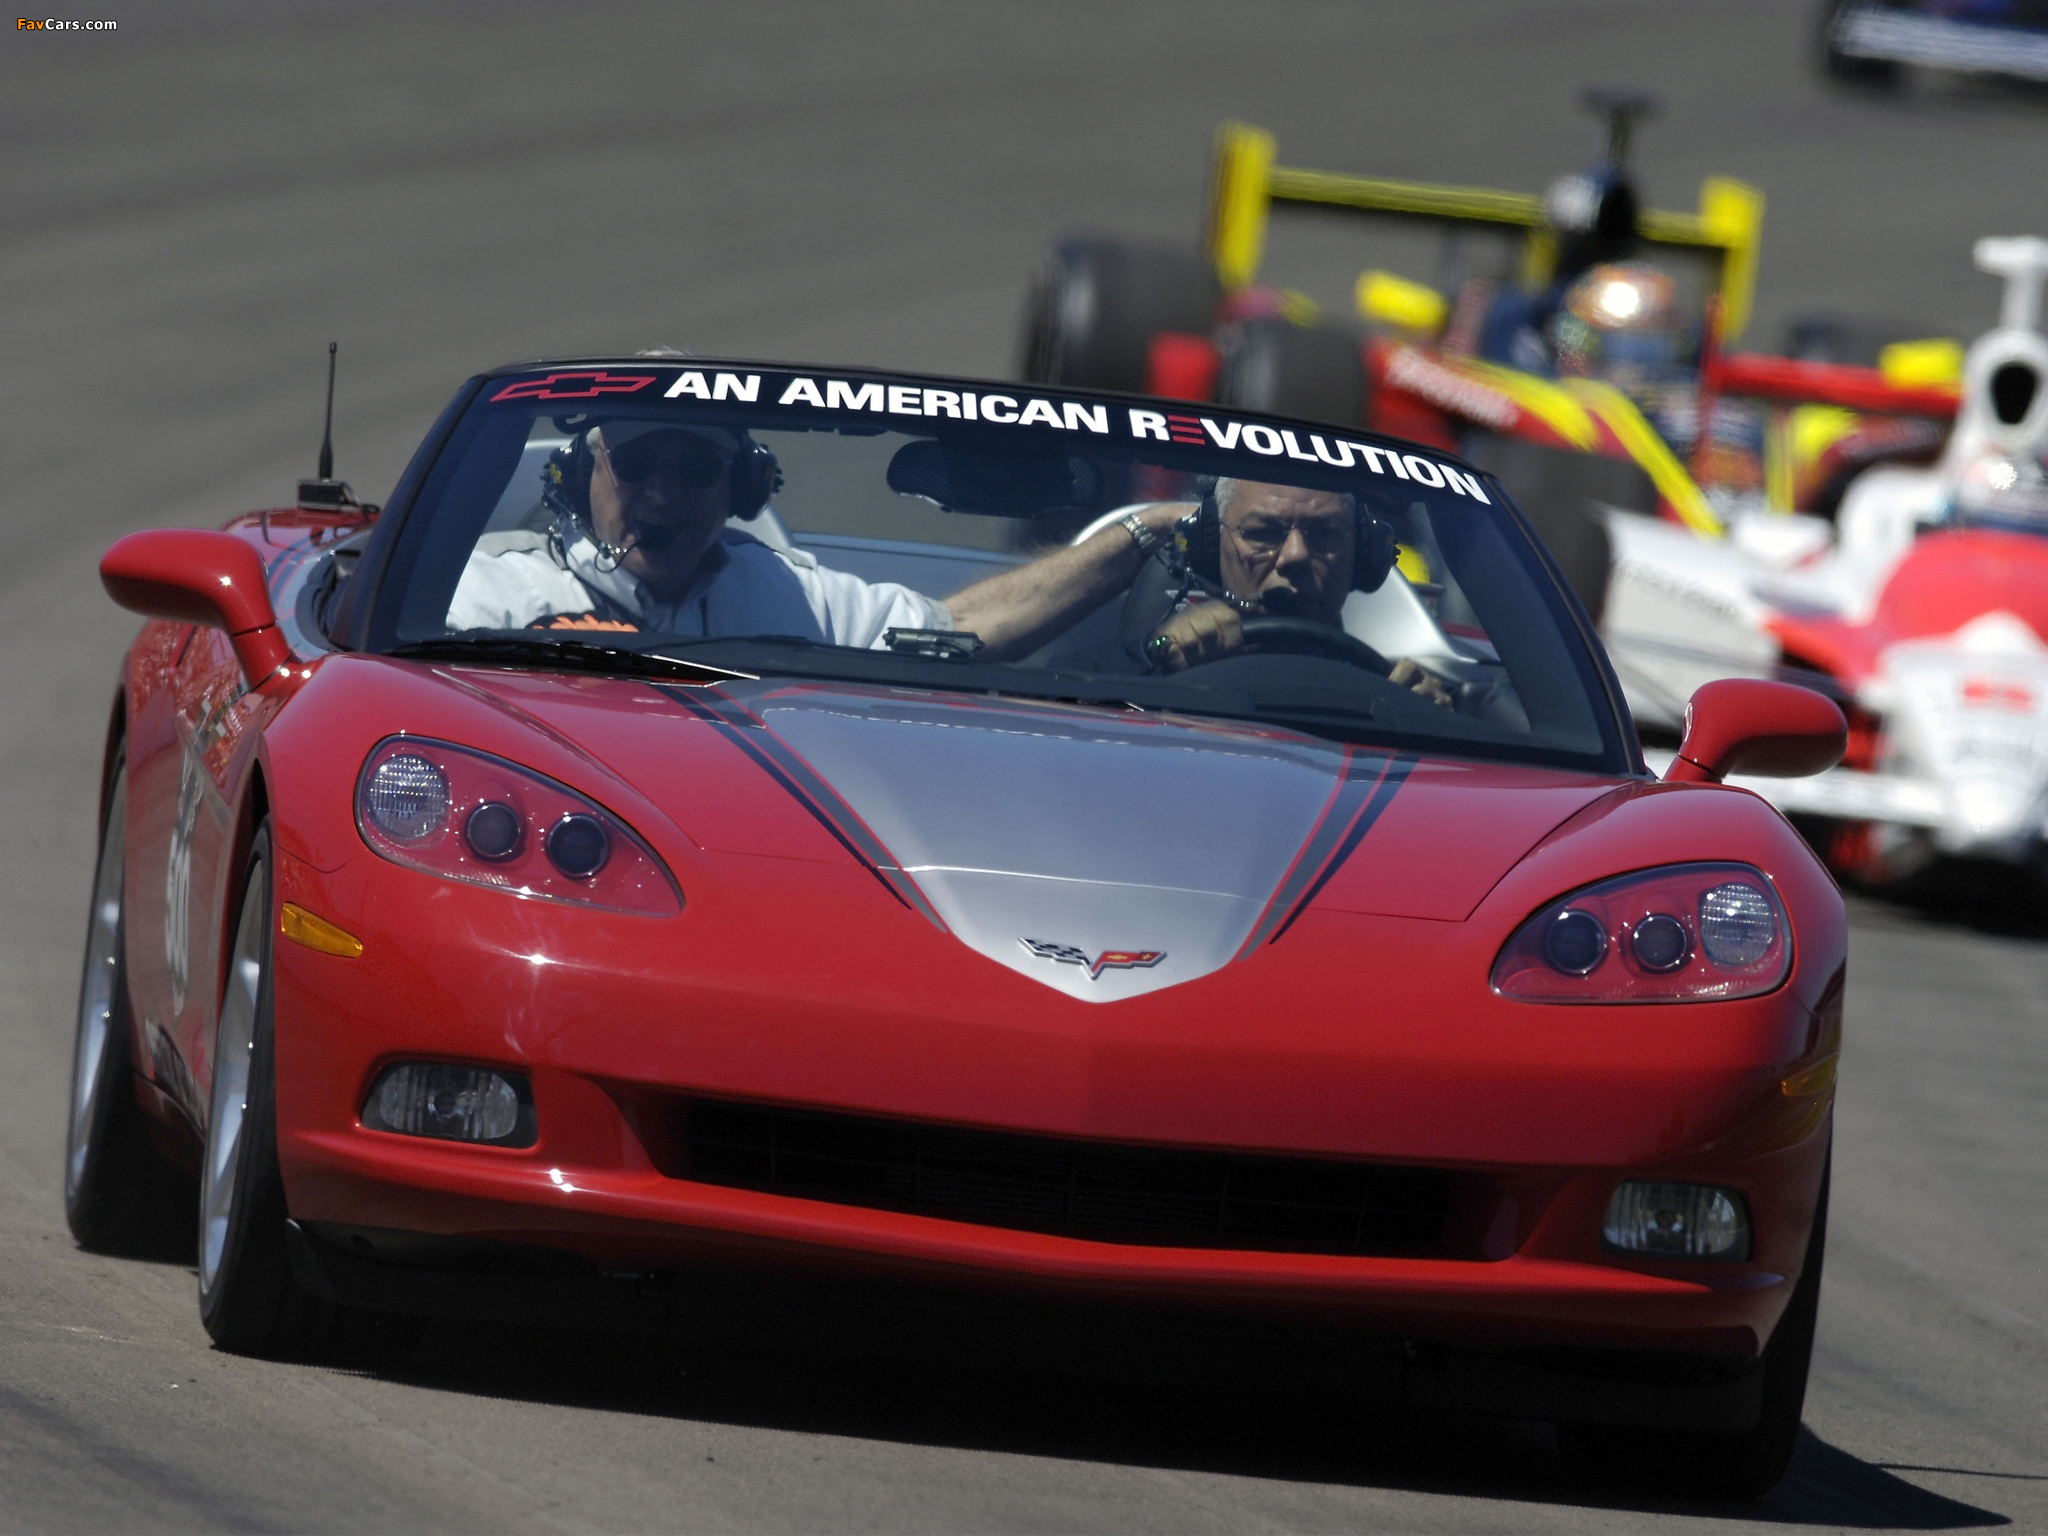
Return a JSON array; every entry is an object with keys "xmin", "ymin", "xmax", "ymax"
[{"xmin": 100, "ymin": 528, "xmax": 291, "ymax": 688}]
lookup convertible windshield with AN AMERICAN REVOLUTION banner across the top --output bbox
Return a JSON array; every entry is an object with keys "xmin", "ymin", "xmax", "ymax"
[{"xmin": 373, "ymin": 365, "xmax": 1628, "ymax": 772}]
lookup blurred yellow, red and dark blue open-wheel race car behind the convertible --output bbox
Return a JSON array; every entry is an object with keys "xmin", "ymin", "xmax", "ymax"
[{"xmin": 1022, "ymin": 92, "xmax": 1960, "ymax": 667}]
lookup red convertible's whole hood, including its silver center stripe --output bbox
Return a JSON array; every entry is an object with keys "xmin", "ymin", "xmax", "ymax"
[{"xmin": 444, "ymin": 670, "xmax": 1624, "ymax": 1001}]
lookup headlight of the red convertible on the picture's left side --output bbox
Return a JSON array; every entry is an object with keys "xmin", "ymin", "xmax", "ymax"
[{"xmin": 356, "ymin": 735, "xmax": 682, "ymax": 918}]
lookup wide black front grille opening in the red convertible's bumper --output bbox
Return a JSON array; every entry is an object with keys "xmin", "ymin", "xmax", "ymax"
[{"xmin": 676, "ymin": 1100, "xmax": 1452, "ymax": 1253}]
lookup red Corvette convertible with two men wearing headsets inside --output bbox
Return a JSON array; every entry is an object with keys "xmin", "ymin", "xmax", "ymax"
[{"xmin": 66, "ymin": 356, "xmax": 1845, "ymax": 1491}]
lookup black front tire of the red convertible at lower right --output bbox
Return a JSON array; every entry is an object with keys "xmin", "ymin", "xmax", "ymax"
[{"xmin": 1559, "ymin": 1159, "xmax": 1833, "ymax": 1501}]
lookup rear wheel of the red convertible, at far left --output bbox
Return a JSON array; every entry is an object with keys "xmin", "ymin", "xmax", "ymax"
[{"xmin": 63, "ymin": 765, "xmax": 180, "ymax": 1253}]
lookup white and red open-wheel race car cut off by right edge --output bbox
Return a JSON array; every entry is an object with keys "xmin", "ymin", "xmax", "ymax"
[{"xmin": 1604, "ymin": 238, "xmax": 2048, "ymax": 883}]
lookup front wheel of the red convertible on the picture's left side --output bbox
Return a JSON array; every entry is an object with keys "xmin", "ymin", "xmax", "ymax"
[{"xmin": 199, "ymin": 823, "xmax": 332, "ymax": 1358}]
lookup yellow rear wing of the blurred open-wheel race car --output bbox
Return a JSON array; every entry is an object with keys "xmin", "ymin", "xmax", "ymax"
[{"xmin": 1206, "ymin": 123, "xmax": 1763, "ymax": 342}]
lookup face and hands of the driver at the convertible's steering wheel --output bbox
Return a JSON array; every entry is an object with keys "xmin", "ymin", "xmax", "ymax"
[{"xmin": 1145, "ymin": 479, "xmax": 1452, "ymax": 707}]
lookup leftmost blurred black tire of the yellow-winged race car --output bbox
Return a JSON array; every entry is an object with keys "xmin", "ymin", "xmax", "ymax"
[{"xmin": 1022, "ymin": 236, "xmax": 1223, "ymax": 393}]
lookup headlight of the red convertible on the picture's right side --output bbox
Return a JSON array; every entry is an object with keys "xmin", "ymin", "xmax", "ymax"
[{"xmin": 1493, "ymin": 864, "xmax": 1792, "ymax": 1004}]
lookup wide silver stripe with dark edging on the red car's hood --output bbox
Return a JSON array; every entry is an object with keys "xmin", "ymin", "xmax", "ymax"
[{"xmin": 659, "ymin": 682, "xmax": 1411, "ymax": 1001}]
